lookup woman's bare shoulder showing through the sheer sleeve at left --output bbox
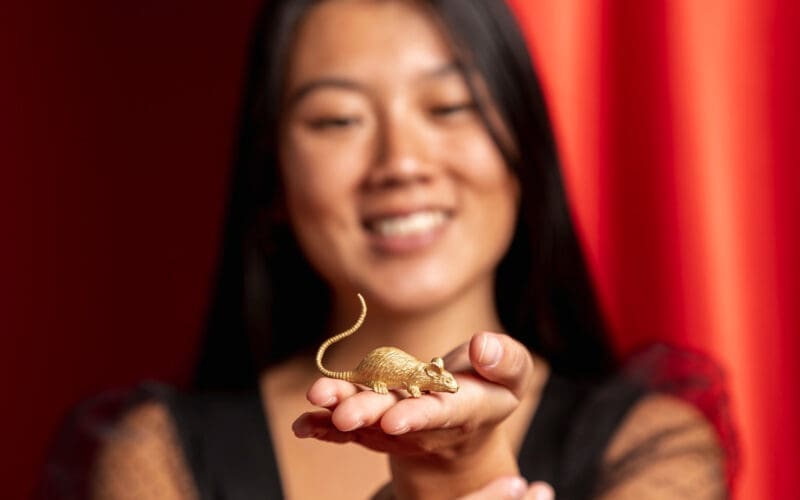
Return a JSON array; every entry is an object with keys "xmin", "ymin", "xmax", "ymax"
[{"xmin": 89, "ymin": 394, "xmax": 196, "ymax": 500}]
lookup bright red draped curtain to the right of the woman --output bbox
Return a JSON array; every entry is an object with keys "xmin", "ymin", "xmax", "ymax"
[{"xmin": 511, "ymin": 0, "xmax": 800, "ymax": 499}]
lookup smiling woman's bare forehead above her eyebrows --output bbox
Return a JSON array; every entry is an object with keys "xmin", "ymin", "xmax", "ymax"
[{"xmin": 287, "ymin": 0, "xmax": 453, "ymax": 87}]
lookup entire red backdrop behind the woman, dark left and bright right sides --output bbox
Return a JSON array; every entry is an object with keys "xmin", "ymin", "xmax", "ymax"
[{"xmin": 0, "ymin": 0, "xmax": 800, "ymax": 499}]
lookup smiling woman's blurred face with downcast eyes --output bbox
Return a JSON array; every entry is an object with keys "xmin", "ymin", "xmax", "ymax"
[{"xmin": 280, "ymin": 0, "xmax": 519, "ymax": 312}]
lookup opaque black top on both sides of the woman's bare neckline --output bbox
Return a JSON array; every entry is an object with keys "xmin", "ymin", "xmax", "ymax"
[{"xmin": 159, "ymin": 374, "xmax": 645, "ymax": 500}]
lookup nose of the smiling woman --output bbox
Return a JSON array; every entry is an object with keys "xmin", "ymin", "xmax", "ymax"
[{"xmin": 367, "ymin": 108, "xmax": 433, "ymax": 189}]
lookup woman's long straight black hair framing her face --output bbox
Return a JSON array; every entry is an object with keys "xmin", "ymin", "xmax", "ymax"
[{"xmin": 194, "ymin": 0, "xmax": 615, "ymax": 390}]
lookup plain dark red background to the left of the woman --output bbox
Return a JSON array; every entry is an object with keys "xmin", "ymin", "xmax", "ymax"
[{"xmin": 0, "ymin": 0, "xmax": 258, "ymax": 498}]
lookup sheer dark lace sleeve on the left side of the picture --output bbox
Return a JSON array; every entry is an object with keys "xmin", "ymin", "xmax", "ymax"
[{"xmin": 34, "ymin": 383, "xmax": 197, "ymax": 500}]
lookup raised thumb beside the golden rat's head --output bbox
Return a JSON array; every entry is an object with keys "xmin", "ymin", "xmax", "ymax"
[{"xmin": 469, "ymin": 332, "xmax": 533, "ymax": 399}]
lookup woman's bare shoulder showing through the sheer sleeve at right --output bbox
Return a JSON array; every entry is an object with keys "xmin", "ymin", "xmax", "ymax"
[{"xmin": 599, "ymin": 393, "xmax": 726, "ymax": 499}]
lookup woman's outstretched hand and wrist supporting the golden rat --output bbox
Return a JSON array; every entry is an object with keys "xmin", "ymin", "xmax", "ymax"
[{"xmin": 293, "ymin": 332, "xmax": 533, "ymax": 498}]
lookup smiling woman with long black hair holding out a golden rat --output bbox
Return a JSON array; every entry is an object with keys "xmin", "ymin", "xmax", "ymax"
[{"xmin": 83, "ymin": 0, "xmax": 725, "ymax": 498}]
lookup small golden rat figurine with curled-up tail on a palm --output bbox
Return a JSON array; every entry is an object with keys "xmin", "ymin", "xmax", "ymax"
[{"xmin": 317, "ymin": 293, "xmax": 458, "ymax": 398}]
